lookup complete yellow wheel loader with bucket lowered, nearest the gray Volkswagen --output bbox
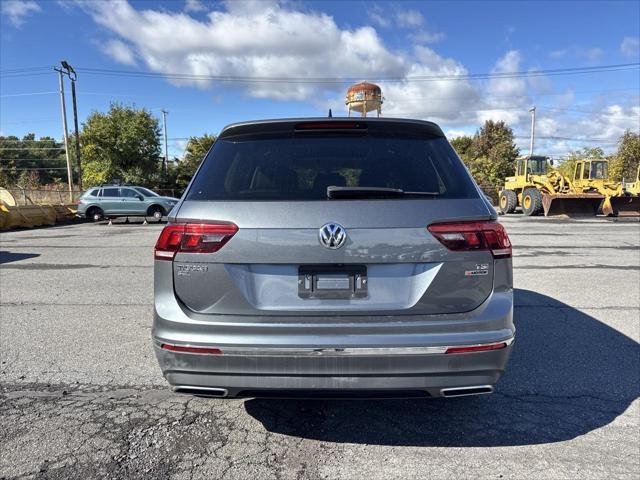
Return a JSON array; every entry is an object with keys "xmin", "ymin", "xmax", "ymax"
[{"xmin": 499, "ymin": 155, "xmax": 604, "ymax": 216}]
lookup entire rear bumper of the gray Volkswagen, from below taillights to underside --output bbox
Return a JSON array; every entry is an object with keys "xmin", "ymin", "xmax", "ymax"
[{"xmin": 152, "ymin": 255, "xmax": 515, "ymax": 397}]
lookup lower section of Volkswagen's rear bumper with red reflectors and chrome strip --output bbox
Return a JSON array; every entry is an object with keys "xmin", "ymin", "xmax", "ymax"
[{"xmin": 155, "ymin": 345, "xmax": 511, "ymax": 397}]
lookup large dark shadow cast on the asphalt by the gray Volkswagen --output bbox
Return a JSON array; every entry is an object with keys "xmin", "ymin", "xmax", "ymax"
[{"xmin": 245, "ymin": 290, "xmax": 640, "ymax": 447}]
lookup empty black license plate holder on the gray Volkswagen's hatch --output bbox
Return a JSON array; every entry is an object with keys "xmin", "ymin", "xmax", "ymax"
[{"xmin": 298, "ymin": 265, "xmax": 369, "ymax": 300}]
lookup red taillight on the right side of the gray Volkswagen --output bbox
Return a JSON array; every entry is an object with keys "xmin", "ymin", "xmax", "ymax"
[{"xmin": 427, "ymin": 222, "xmax": 511, "ymax": 258}]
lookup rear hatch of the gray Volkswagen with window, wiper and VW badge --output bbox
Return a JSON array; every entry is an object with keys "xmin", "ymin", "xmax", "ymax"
[{"xmin": 164, "ymin": 120, "xmax": 497, "ymax": 317}]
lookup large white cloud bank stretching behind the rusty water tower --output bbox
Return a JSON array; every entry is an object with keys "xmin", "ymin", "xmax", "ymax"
[{"xmin": 69, "ymin": 0, "xmax": 639, "ymax": 153}]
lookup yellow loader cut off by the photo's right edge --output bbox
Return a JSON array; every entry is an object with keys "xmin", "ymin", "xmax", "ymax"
[{"xmin": 572, "ymin": 159, "xmax": 640, "ymax": 216}]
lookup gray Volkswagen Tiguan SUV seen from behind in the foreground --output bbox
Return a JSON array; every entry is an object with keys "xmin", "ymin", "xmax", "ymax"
[{"xmin": 152, "ymin": 119, "xmax": 515, "ymax": 398}]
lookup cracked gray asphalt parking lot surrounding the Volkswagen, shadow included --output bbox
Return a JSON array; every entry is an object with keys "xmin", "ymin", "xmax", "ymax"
[{"xmin": 0, "ymin": 216, "xmax": 640, "ymax": 479}]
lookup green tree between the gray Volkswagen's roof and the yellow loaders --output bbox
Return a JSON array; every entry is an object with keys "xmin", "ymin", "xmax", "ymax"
[{"xmin": 463, "ymin": 120, "xmax": 519, "ymax": 191}]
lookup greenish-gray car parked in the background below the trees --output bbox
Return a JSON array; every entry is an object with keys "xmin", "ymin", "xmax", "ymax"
[{"xmin": 78, "ymin": 185, "xmax": 180, "ymax": 221}]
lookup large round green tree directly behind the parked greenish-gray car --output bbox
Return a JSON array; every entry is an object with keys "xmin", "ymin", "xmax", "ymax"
[{"xmin": 80, "ymin": 104, "xmax": 160, "ymax": 186}]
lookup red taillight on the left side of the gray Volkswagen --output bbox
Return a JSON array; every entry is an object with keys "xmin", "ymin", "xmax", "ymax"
[{"xmin": 154, "ymin": 223, "xmax": 238, "ymax": 260}]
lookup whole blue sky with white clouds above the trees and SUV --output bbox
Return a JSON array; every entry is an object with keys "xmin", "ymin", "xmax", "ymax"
[{"xmin": 0, "ymin": 0, "xmax": 640, "ymax": 156}]
